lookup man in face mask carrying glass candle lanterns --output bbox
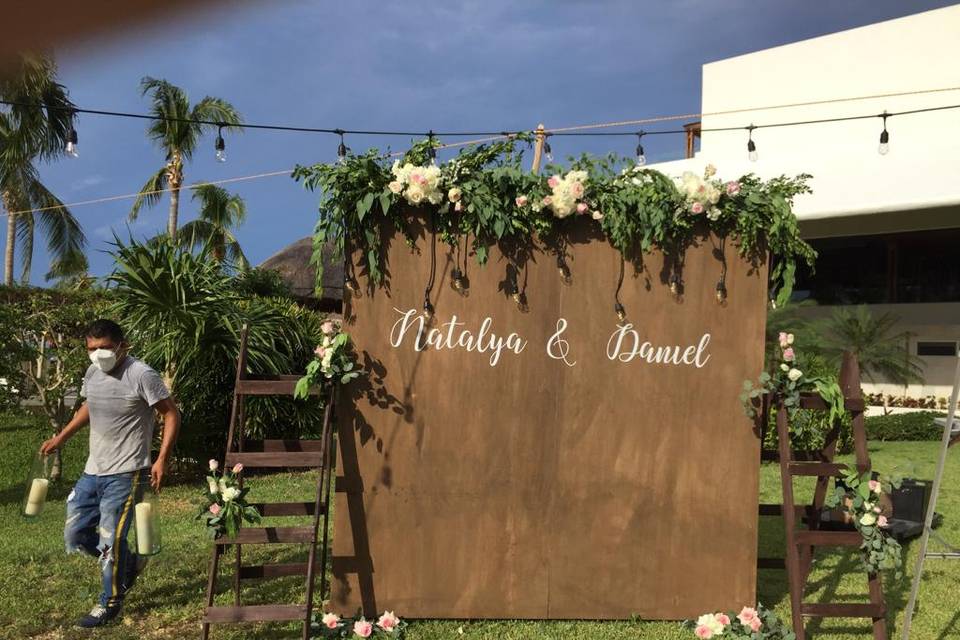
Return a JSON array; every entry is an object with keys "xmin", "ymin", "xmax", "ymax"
[{"xmin": 40, "ymin": 320, "xmax": 180, "ymax": 628}]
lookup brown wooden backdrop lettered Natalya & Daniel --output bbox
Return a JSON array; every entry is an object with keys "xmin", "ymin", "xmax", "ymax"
[{"xmin": 332, "ymin": 219, "xmax": 767, "ymax": 619}]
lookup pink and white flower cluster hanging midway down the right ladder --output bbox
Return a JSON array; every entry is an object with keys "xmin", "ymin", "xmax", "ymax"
[{"xmin": 825, "ymin": 469, "xmax": 903, "ymax": 578}]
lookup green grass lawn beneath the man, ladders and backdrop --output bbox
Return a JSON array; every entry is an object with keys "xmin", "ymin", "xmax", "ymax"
[{"xmin": 0, "ymin": 416, "xmax": 960, "ymax": 640}]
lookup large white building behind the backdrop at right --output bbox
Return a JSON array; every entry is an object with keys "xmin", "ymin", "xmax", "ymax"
[{"xmin": 656, "ymin": 6, "xmax": 960, "ymax": 397}]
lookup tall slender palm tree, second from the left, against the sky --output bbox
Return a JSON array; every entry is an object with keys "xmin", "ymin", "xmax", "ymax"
[{"xmin": 130, "ymin": 76, "xmax": 240, "ymax": 238}]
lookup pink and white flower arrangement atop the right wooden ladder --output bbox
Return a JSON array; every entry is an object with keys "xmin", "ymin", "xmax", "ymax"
[{"xmin": 740, "ymin": 331, "xmax": 844, "ymax": 423}]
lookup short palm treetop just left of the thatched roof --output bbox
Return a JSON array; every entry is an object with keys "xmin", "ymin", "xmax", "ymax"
[{"xmin": 177, "ymin": 184, "xmax": 250, "ymax": 271}]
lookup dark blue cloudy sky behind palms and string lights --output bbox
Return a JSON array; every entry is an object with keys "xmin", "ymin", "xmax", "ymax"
[{"xmin": 11, "ymin": 0, "xmax": 953, "ymax": 284}]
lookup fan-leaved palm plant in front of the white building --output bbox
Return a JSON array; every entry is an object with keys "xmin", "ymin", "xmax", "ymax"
[{"xmin": 820, "ymin": 305, "xmax": 923, "ymax": 385}]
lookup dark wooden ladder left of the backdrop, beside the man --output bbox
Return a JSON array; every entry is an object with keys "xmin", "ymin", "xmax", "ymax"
[{"xmin": 203, "ymin": 326, "xmax": 335, "ymax": 640}]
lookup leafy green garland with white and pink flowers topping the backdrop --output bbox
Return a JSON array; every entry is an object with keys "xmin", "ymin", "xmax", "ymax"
[{"xmin": 293, "ymin": 134, "xmax": 816, "ymax": 303}]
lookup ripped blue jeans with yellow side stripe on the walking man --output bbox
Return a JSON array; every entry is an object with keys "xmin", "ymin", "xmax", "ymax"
[{"xmin": 63, "ymin": 469, "xmax": 150, "ymax": 607}]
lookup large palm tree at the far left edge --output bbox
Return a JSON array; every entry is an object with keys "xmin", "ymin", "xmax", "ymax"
[{"xmin": 0, "ymin": 54, "xmax": 86, "ymax": 285}]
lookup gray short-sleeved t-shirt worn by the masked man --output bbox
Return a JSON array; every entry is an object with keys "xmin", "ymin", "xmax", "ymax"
[{"xmin": 80, "ymin": 356, "xmax": 170, "ymax": 476}]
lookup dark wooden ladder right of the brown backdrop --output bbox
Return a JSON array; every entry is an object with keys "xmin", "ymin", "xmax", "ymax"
[{"xmin": 757, "ymin": 353, "xmax": 887, "ymax": 640}]
